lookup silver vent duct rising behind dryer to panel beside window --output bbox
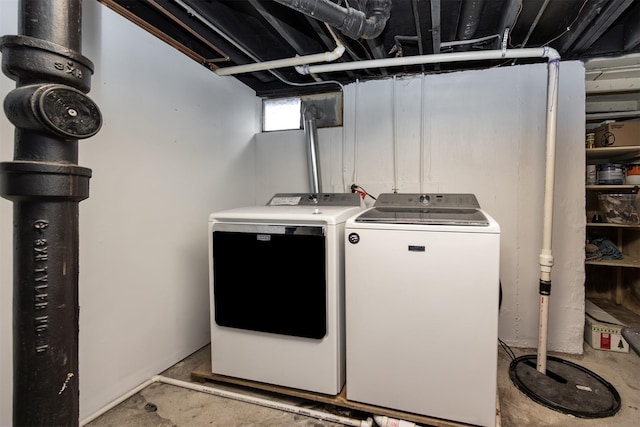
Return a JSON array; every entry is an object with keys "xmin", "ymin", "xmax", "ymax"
[{"xmin": 300, "ymin": 93, "xmax": 342, "ymax": 194}]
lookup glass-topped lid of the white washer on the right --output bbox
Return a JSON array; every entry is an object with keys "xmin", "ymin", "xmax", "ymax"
[{"xmin": 355, "ymin": 207, "xmax": 489, "ymax": 226}]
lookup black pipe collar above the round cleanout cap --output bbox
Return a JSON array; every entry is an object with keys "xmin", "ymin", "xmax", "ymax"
[{"xmin": 0, "ymin": 36, "xmax": 93, "ymax": 93}]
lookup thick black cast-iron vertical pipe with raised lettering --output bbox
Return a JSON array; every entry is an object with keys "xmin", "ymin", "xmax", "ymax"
[{"xmin": 0, "ymin": 0, "xmax": 101, "ymax": 426}]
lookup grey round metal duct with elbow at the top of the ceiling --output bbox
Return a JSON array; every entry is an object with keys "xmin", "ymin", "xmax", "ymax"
[{"xmin": 275, "ymin": 0, "xmax": 391, "ymax": 39}]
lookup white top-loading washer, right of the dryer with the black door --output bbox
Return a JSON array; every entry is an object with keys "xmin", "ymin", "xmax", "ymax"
[{"xmin": 345, "ymin": 194, "xmax": 500, "ymax": 426}]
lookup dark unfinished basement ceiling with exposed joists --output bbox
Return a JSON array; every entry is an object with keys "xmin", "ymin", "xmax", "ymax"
[{"xmin": 99, "ymin": 0, "xmax": 640, "ymax": 97}]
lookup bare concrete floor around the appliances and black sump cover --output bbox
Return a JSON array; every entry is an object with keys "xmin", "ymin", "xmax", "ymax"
[{"xmin": 86, "ymin": 344, "xmax": 640, "ymax": 427}]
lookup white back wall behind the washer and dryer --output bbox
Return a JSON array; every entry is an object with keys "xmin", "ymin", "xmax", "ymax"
[{"xmin": 256, "ymin": 62, "xmax": 585, "ymax": 353}]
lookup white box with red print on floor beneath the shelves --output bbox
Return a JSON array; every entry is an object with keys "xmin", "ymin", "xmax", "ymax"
[{"xmin": 584, "ymin": 300, "xmax": 629, "ymax": 353}]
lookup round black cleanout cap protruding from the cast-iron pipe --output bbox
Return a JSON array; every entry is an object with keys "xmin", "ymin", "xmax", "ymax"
[{"xmin": 4, "ymin": 84, "xmax": 102, "ymax": 140}]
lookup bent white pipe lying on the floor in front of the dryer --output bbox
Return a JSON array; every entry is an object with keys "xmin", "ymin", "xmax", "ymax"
[{"xmin": 80, "ymin": 375, "xmax": 373, "ymax": 427}]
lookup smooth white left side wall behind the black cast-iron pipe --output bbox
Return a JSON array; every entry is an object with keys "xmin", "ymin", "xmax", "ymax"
[{"xmin": 0, "ymin": 0, "xmax": 260, "ymax": 426}]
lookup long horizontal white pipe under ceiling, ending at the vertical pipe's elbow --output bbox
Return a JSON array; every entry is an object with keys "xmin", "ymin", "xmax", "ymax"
[{"xmin": 296, "ymin": 47, "xmax": 560, "ymax": 74}]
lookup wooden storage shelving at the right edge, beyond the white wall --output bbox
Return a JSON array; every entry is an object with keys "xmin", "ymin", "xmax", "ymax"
[{"xmin": 585, "ymin": 56, "xmax": 640, "ymax": 332}]
